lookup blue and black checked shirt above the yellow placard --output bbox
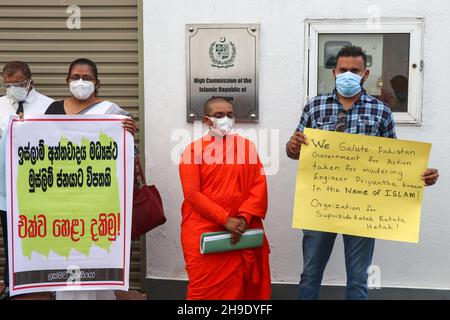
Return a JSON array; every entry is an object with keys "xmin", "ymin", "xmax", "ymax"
[{"xmin": 297, "ymin": 89, "xmax": 396, "ymax": 138}]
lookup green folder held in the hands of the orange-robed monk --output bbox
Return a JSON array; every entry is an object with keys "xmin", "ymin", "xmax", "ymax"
[{"xmin": 200, "ymin": 229, "xmax": 264, "ymax": 254}]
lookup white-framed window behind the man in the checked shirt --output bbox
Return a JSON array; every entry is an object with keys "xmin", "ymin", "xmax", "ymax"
[{"xmin": 306, "ymin": 19, "xmax": 423, "ymax": 125}]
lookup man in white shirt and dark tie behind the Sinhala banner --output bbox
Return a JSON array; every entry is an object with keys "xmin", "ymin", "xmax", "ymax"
[{"xmin": 0, "ymin": 61, "xmax": 53, "ymax": 300}]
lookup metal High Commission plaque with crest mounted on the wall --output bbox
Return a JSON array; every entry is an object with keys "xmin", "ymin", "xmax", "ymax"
[{"xmin": 186, "ymin": 24, "xmax": 259, "ymax": 122}]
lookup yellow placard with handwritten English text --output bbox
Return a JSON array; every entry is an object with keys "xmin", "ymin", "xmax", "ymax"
[{"xmin": 292, "ymin": 128, "xmax": 431, "ymax": 243}]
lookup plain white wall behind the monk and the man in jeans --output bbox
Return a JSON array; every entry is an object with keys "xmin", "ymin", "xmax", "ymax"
[{"xmin": 144, "ymin": 0, "xmax": 450, "ymax": 288}]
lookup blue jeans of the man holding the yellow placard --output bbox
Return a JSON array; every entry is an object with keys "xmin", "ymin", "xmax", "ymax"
[{"xmin": 298, "ymin": 230, "xmax": 375, "ymax": 300}]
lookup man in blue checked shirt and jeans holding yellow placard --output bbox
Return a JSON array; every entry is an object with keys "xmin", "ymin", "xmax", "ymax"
[{"xmin": 286, "ymin": 46, "xmax": 439, "ymax": 299}]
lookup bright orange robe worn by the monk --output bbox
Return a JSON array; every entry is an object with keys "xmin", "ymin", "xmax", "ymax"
[{"xmin": 179, "ymin": 134, "xmax": 271, "ymax": 300}]
